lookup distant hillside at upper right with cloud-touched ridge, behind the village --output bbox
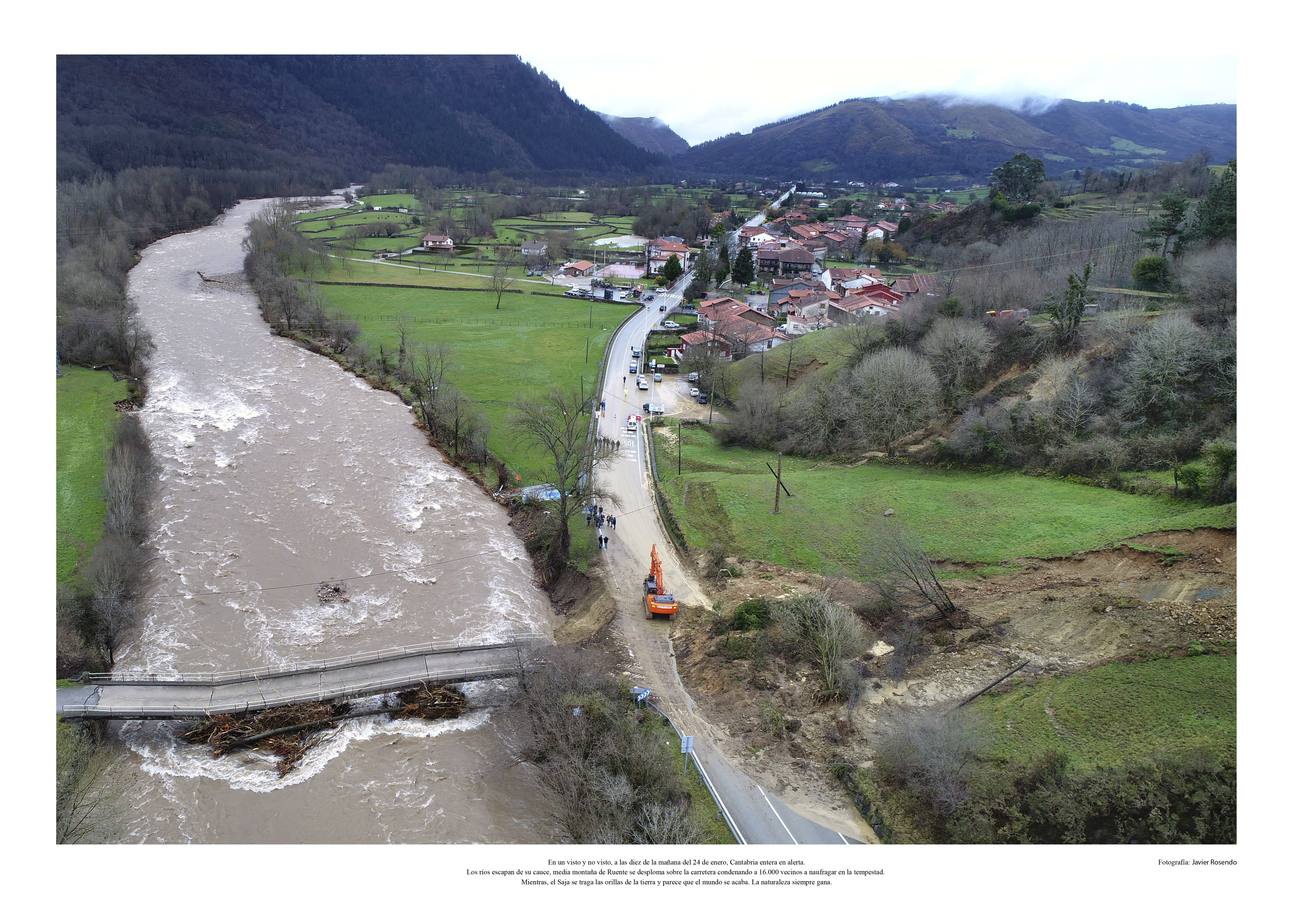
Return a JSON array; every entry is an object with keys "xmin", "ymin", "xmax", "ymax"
[{"xmin": 678, "ymin": 97, "xmax": 1235, "ymax": 181}]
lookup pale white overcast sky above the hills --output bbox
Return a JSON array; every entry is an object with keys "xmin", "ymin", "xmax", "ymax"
[{"xmin": 522, "ymin": 51, "xmax": 1236, "ymax": 144}]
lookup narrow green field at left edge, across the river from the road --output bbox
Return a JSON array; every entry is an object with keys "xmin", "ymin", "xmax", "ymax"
[{"xmin": 54, "ymin": 366, "xmax": 125, "ymax": 583}]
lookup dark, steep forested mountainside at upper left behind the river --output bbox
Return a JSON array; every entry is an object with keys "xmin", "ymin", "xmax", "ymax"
[{"xmin": 58, "ymin": 56, "xmax": 659, "ymax": 184}]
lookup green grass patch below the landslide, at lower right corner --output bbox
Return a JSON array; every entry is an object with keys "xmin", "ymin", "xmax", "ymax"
[{"xmin": 971, "ymin": 653, "xmax": 1236, "ymax": 769}]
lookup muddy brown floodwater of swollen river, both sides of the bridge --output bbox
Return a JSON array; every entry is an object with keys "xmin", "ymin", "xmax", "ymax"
[{"xmin": 102, "ymin": 200, "xmax": 555, "ymax": 843}]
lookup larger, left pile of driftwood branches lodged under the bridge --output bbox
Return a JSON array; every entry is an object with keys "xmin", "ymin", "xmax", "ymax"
[{"xmin": 184, "ymin": 702, "xmax": 350, "ymax": 777}]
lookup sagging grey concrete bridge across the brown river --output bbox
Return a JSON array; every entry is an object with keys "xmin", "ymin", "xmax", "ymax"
[{"xmin": 57, "ymin": 641, "xmax": 526, "ymax": 719}]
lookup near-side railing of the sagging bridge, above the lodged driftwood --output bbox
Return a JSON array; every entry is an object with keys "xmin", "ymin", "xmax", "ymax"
[{"xmin": 59, "ymin": 663, "xmax": 535, "ymax": 719}]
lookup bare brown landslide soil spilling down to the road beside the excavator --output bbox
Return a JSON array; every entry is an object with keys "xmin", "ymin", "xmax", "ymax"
[{"xmin": 674, "ymin": 529, "xmax": 1236, "ymax": 822}]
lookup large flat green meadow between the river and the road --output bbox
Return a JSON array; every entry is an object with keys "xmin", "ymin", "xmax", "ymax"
[{"xmin": 307, "ymin": 265, "xmax": 636, "ymax": 484}]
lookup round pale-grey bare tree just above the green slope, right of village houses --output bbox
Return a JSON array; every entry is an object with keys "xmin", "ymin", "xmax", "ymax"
[{"xmin": 851, "ymin": 347, "xmax": 939, "ymax": 456}]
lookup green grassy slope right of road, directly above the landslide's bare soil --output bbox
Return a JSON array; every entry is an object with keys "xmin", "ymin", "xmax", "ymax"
[{"xmin": 659, "ymin": 427, "xmax": 1235, "ymax": 573}]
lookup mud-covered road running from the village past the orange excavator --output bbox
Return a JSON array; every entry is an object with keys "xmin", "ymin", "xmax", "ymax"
[{"xmin": 597, "ymin": 204, "xmax": 865, "ymax": 844}]
